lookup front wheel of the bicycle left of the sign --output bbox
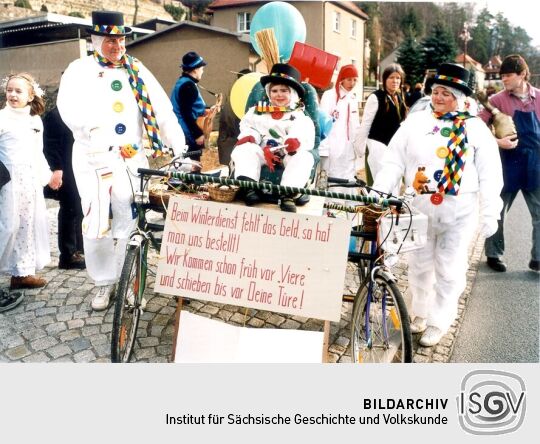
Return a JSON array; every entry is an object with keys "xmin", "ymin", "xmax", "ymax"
[{"xmin": 111, "ymin": 245, "xmax": 142, "ymax": 362}]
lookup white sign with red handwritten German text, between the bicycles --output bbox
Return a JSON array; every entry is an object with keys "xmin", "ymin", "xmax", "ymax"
[{"xmin": 155, "ymin": 196, "xmax": 351, "ymax": 321}]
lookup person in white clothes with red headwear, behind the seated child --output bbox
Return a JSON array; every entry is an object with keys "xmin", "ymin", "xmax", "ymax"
[{"xmin": 319, "ymin": 65, "xmax": 360, "ymax": 186}]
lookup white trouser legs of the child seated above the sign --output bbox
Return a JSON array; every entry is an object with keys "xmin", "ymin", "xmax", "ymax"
[{"xmin": 231, "ymin": 143, "xmax": 315, "ymax": 188}]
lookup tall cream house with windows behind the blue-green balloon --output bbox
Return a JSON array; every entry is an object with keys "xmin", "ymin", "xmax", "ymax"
[{"xmin": 209, "ymin": 0, "xmax": 368, "ymax": 92}]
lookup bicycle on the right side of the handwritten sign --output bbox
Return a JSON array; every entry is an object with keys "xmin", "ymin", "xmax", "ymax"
[{"xmin": 325, "ymin": 177, "xmax": 423, "ymax": 362}]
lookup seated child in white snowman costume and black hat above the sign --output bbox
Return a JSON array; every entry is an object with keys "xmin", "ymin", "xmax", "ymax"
[{"xmin": 231, "ymin": 63, "xmax": 315, "ymax": 213}]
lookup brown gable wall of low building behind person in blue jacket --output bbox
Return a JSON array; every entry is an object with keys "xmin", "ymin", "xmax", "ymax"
[{"xmin": 127, "ymin": 21, "xmax": 251, "ymax": 105}]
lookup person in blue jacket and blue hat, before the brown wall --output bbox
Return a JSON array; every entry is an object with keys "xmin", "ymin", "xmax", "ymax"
[{"xmin": 171, "ymin": 51, "xmax": 206, "ymax": 169}]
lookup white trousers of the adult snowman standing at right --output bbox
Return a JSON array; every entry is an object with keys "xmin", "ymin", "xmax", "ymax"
[{"xmin": 408, "ymin": 193, "xmax": 478, "ymax": 332}]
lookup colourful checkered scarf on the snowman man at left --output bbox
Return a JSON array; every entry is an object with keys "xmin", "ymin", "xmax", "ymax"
[{"xmin": 94, "ymin": 51, "xmax": 163, "ymax": 157}]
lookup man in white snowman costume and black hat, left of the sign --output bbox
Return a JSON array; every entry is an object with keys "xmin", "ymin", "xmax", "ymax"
[{"xmin": 57, "ymin": 11, "xmax": 185, "ymax": 310}]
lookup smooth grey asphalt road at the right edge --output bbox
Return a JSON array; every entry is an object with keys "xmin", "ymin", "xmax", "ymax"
[{"xmin": 451, "ymin": 194, "xmax": 540, "ymax": 362}]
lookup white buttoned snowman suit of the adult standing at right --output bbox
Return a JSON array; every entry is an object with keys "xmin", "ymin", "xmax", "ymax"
[{"xmin": 373, "ymin": 64, "xmax": 503, "ymax": 345}]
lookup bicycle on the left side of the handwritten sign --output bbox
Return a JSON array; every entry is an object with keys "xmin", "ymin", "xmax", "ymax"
[{"xmin": 111, "ymin": 154, "xmax": 210, "ymax": 362}]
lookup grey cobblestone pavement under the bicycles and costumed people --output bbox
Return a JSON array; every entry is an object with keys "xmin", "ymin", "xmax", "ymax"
[{"xmin": 0, "ymin": 201, "xmax": 483, "ymax": 363}]
